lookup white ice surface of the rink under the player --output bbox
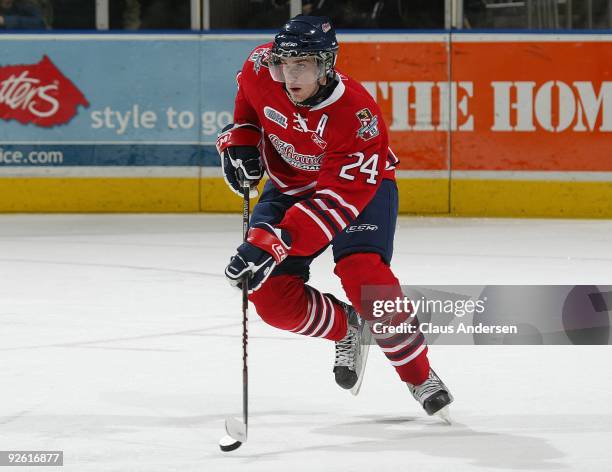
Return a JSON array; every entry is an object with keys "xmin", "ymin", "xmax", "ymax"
[{"xmin": 0, "ymin": 215, "xmax": 612, "ymax": 472}]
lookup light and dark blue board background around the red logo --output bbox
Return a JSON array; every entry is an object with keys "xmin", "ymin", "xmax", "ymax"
[{"xmin": 0, "ymin": 35, "xmax": 263, "ymax": 166}]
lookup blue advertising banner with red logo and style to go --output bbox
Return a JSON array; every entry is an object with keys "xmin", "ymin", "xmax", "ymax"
[{"xmin": 0, "ymin": 35, "xmax": 266, "ymax": 170}]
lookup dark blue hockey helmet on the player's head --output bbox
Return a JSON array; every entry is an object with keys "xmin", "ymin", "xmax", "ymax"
[{"xmin": 272, "ymin": 15, "xmax": 338, "ymax": 76}]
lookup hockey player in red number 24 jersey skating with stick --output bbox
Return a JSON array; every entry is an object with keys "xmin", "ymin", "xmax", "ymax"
[{"xmin": 217, "ymin": 15, "xmax": 453, "ymax": 415}]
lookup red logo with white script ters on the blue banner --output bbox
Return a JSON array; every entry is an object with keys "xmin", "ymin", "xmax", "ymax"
[{"xmin": 0, "ymin": 56, "xmax": 89, "ymax": 127}]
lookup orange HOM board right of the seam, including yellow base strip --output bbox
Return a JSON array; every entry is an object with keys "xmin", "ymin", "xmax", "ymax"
[{"xmin": 450, "ymin": 34, "xmax": 612, "ymax": 218}]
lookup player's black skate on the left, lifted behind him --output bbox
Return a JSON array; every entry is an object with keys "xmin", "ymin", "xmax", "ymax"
[{"xmin": 326, "ymin": 294, "xmax": 372, "ymax": 395}]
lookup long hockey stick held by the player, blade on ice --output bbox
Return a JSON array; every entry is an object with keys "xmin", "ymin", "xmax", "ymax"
[{"xmin": 219, "ymin": 180, "xmax": 251, "ymax": 452}]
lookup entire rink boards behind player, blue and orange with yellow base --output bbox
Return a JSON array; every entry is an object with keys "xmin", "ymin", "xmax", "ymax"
[{"xmin": 0, "ymin": 33, "xmax": 612, "ymax": 218}]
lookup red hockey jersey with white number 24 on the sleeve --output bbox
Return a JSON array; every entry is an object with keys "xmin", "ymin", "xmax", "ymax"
[{"xmin": 234, "ymin": 43, "xmax": 397, "ymax": 256}]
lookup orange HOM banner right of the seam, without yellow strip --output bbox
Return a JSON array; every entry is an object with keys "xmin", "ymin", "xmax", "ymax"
[{"xmin": 452, "ymin": 35, "xmax": 612, "ymax": 172}]
